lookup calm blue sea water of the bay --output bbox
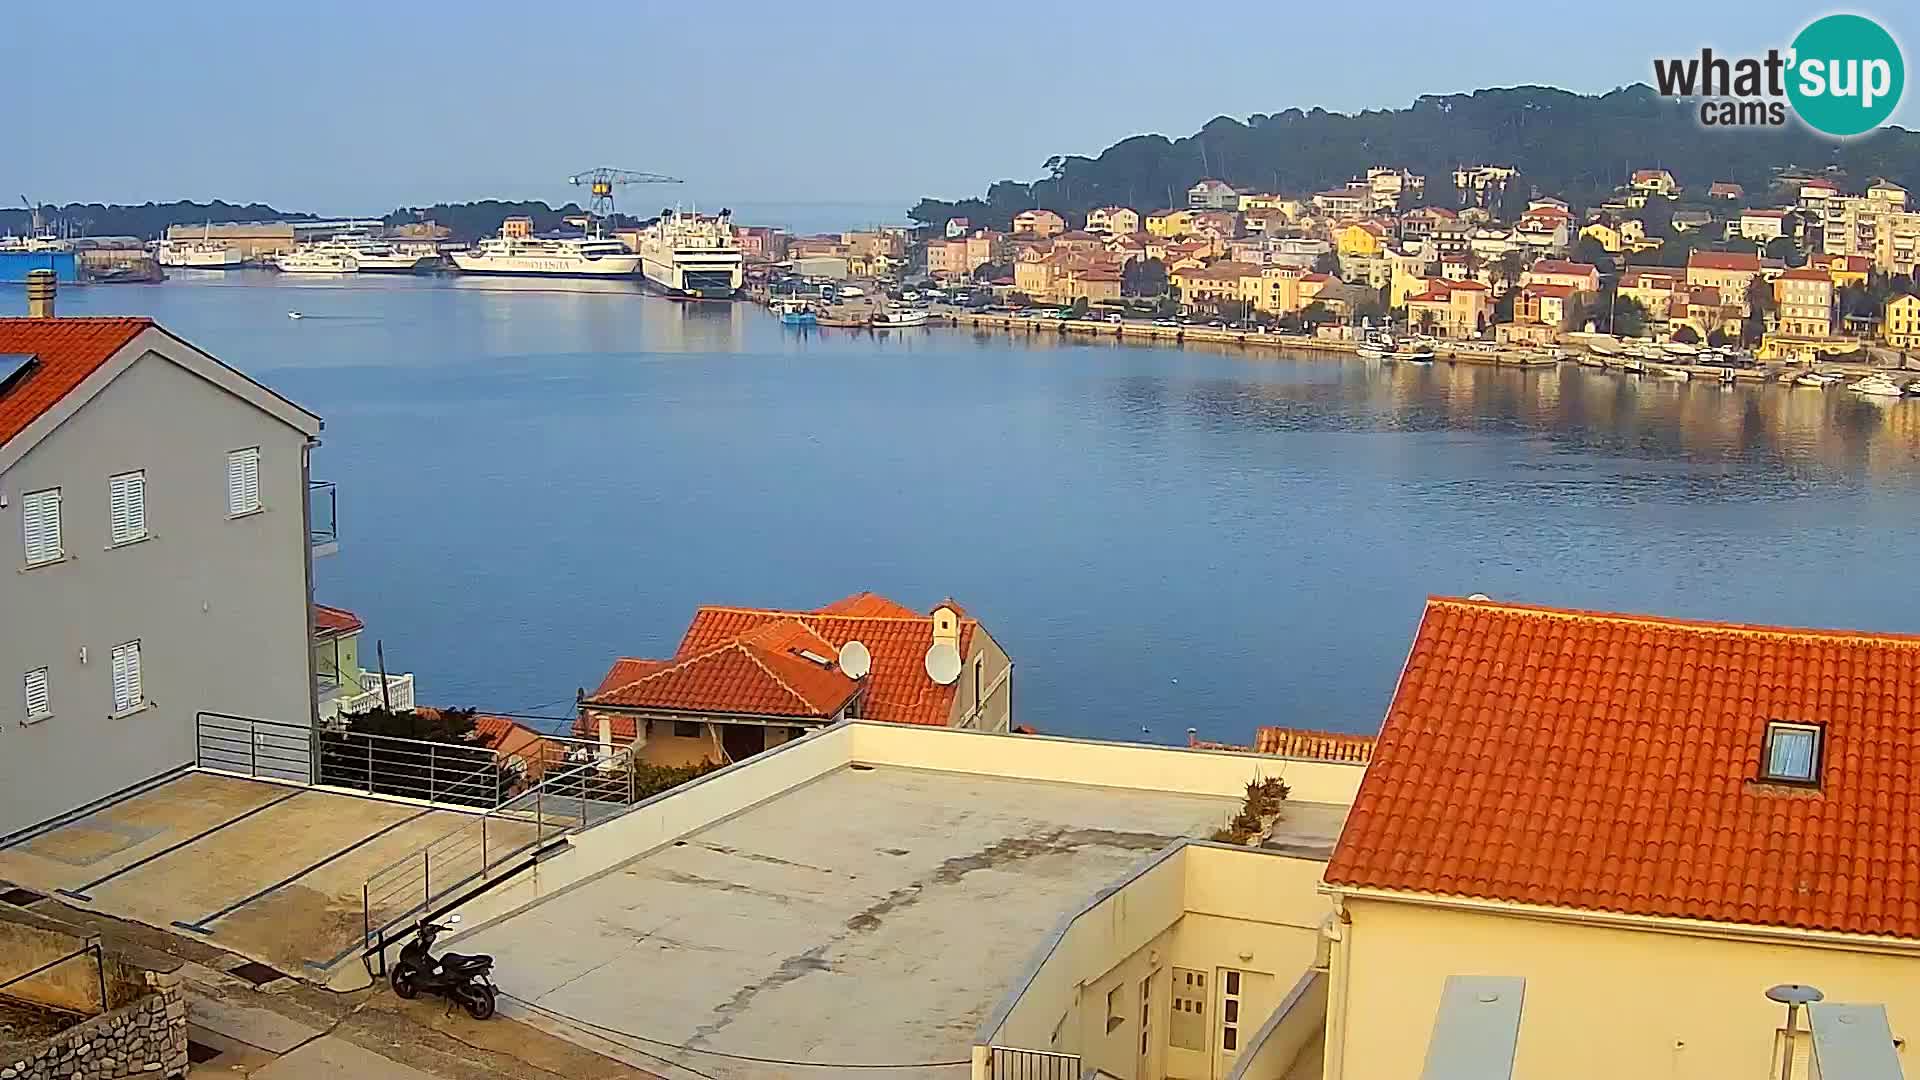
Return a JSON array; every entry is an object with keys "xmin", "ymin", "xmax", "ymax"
[{"xmin": 45, "ymin": 273, "xmax": 1920, "ymax": 742}]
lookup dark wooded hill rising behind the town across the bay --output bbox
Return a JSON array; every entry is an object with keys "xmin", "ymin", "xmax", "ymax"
[{"xmin": 908, "ymin": 83, "xmax": 1920, "ymax": 229}]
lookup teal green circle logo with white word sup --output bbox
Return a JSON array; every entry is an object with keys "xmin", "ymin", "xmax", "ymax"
[{"xmin": 1788, "ymin": 15, "xmax": 1907, "ymax": 135}]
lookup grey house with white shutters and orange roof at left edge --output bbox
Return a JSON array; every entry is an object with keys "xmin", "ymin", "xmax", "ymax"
[{"xmin": 0, "ymin": 319, "xmax": 321, "ymax": 840}]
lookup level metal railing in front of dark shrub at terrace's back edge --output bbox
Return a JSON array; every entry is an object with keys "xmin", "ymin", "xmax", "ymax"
[{"xmin": 315, "ymin": 722, "xmax": 522, "ymax": 809}]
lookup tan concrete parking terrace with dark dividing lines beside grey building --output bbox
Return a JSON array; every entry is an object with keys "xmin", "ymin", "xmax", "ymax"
[{"xmin": 0, "ymin": 773, "xmax": 533, "ymax": 978}]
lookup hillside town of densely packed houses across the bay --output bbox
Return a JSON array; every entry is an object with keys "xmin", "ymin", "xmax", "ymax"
[{"xmin": 735, "ymin": 165, "xmax": 1920, "ymax": 361}]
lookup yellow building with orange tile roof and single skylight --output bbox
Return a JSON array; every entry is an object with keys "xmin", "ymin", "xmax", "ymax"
[{"xmin": 1328, "ymin": 600, "xmax": 1920, "ymax": 1080}]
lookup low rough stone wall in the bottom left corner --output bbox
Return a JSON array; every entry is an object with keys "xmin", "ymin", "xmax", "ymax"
[{"xmin": 0, "ymin": 970, "xmax": 186, "ymax": 1080}]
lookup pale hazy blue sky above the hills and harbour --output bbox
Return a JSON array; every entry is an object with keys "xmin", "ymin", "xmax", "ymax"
[{"xmin": 11, "ymin": 0, "xmax": 1920, "ymax": 213}]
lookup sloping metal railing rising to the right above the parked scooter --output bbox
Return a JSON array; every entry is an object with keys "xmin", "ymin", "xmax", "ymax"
[{"xmin": 361, "ymin": 749, "xmax": 636, "ymax": 949}]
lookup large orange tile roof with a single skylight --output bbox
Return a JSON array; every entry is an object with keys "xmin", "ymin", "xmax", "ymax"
[{"xmin": 1327, "ymin": 598, "xmax": 1920, "ymax": 938}]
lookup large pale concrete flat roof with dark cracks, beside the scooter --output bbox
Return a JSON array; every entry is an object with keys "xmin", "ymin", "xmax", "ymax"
[{"xmin": 451, "ymin": 765, "xmax": 1346, "ymax": 1078}]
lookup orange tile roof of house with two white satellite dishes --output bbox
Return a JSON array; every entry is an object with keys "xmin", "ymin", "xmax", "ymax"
[{"xmin": 576, "ymin": 592, "xmax": 979, "ymax": 740}]
